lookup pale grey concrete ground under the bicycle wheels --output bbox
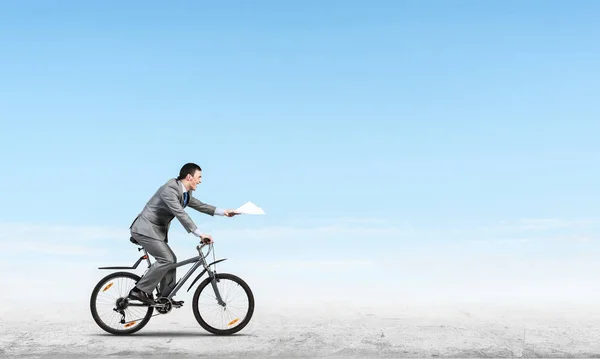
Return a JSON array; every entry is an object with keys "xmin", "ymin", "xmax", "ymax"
[{"xmin": 0, "ymin": 302, "xmax": 600, "ymax": 358}]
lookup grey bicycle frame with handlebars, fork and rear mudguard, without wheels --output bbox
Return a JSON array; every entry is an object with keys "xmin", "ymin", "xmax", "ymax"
[{"xmin": 98, "ymin": 240, "xmax": 227, "ymax": 305}]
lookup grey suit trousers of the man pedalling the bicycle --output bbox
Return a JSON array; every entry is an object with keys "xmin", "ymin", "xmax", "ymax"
[{"xmin": 131, "ymin": 232, "xmax": 177, "ymax": 297}]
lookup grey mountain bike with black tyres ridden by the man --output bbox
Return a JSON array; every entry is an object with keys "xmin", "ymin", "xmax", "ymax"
[{"xmin": 90, "ymin": 237, "xmax": 254, "ymax": 335}]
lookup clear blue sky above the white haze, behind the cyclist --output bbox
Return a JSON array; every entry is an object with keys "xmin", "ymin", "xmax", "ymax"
[{"xmin": 0, "ymin": 1, "xmax": 600, "ymax": 308}]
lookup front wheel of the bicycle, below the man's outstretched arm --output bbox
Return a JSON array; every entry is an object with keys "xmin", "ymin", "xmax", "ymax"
[{"xmin": 192, "ymin": 273, "xmax": 254, "ymax": 335}]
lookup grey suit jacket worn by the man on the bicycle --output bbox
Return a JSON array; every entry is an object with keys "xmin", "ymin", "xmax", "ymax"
[{"xmin": 129, "ymin": 178, "xmax": 216, "ymax": 242}]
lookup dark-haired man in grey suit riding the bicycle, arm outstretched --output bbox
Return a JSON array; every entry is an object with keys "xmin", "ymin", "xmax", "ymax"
[{"xmin": 129, "ymin": 163, "xmax": 238, "ymax": 306}]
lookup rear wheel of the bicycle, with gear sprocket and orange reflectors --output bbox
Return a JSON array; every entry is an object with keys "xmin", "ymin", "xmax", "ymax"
[{"xmin": 90, "ymin": 272, "xmax": 154, "ymax": 335}]
